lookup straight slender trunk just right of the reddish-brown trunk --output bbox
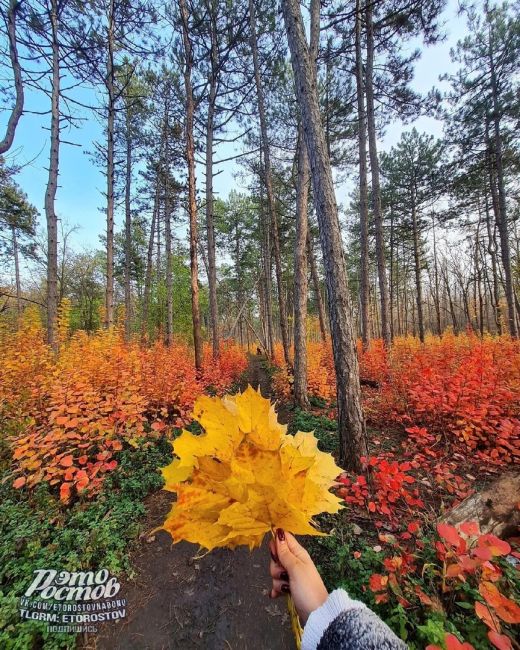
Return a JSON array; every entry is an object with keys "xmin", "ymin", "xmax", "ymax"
[{"xmin": 206, "ymin": 5, "xmax": 219, "ymax": 359}]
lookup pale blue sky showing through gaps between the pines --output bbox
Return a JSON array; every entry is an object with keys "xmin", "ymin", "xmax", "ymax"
[{"xmin": 0, "ymin": 0, "xmax": 465, "ymax": 256}]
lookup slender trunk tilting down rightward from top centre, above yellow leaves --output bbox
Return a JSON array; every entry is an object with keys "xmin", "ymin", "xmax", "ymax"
[{"xmin": 249, "ymin": 0, "xmax": 291, "ymax": 366}]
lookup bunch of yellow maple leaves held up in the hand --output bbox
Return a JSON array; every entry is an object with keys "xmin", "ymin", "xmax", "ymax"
[{"xmin": 160, "ymin": 386, "xmax": 341, "ymax": 550}]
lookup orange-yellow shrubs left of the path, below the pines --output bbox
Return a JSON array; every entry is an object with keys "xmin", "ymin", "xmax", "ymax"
[{"xmin": 0, "ymin": 310, "xmax": 247, "ymax": 502}]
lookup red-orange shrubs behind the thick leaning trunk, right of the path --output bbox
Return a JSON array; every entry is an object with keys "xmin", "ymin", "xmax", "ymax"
[{"xmin": 275, "ymin": 333, "xmax": 520, "ymax": 462}]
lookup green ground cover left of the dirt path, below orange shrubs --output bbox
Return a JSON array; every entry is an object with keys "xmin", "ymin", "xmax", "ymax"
[{"xmin": 0, "ymin": 439, "xmax": 172, "ymax": 650}]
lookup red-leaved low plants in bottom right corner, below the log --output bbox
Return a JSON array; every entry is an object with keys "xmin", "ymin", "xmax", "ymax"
[{"xmin": 369, "ymin": 522, "xmax": 520, "ymax": 650}]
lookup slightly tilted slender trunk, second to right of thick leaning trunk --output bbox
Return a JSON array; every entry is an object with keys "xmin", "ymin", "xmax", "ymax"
[{"xmin": 365, "ymin": 0, "xmax": 392, "ymax": 346}]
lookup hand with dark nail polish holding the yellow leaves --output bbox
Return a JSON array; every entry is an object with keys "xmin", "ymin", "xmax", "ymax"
[{"xmin": 269, "ymin": 528, "xmax": 328, "ymax": 625}]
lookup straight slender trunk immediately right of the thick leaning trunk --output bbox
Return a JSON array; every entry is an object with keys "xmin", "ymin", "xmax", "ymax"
[{"xmin": 356, "ymin": 0, "xmax": 370, "ymax": 348}]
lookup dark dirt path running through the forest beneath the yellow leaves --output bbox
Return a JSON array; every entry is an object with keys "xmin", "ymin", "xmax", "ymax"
[{"xmin": 95, "ymin": 356, "xmax": 295, "ymax": 650}]
